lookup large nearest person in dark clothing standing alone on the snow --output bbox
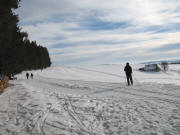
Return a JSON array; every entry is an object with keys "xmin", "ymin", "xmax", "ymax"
[{"xmin": 124, "ymin": 62, "xmax": 133, "ymax": 85}]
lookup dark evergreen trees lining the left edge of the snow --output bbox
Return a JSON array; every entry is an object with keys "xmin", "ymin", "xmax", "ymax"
[{"xmin": 0, "ymin": 0, "xmax": 51, "ymax": 76}]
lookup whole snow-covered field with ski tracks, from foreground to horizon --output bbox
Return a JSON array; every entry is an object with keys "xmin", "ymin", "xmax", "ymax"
[{"xmin": 0, "ymin": 65, "xmax": 180, "ymax": 135}]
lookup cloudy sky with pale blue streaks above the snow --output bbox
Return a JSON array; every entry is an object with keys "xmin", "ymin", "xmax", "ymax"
[{"xmin": 17, "ymin": 0, "xmax": 180, "ymax": 65}]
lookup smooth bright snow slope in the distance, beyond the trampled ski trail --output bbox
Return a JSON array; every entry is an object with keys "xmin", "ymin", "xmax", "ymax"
[{"xmin": 18, "ymin": 64, "xmax": 180, "ymax": 85}]
